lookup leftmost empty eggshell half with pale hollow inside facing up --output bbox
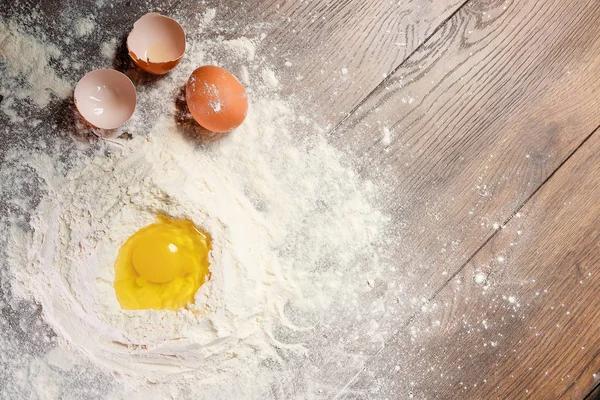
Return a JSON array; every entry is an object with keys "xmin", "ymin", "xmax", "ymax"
[{"xmin": 73, "ymin": 69, "xmax": 136, "ymax": 129}]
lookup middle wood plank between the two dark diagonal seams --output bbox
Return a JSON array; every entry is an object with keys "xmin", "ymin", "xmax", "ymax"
[{"xmin": 316, "ymin": 0, "xmax": 600, "ymax": 394}]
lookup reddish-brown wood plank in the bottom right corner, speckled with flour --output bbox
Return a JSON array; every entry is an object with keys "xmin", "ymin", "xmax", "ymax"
[{"xmin": 344, "ymin": 132, "xmax": 600, "ymax": 399}]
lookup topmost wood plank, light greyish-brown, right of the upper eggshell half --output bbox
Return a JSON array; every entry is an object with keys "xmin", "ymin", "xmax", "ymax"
[{"xmin": 172, "ymin": 0, "xmax": 465, "ymax": 125}]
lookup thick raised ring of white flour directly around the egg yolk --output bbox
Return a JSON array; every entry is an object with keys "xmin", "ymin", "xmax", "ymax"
[{"xmin": 11, "ymin": 111, "xmax": 308, "ymax": 381}]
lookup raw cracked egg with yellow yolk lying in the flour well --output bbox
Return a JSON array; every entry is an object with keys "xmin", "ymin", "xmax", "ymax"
[{"xmin": 115, "ymin": 216, "xmax": 211, "ymax": 310}]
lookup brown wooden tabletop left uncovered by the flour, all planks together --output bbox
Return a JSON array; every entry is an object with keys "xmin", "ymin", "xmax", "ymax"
[{"xmin": 3, "ymin": 0, "xmax": 600, "ymax": 399}]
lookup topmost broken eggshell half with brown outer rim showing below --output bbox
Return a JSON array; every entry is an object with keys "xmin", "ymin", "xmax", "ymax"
[{"xmin": 127, "ymin": 13, "xmax": 185, "ymax": 75}]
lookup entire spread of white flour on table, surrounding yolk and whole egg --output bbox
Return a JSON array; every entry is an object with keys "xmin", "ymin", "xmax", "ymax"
[{"xmin": 0, "ymin": 9, "xmax": 386, "ymax": 399}]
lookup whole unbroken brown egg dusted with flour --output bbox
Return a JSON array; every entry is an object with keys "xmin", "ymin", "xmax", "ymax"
[{"xmin": 185, "ymin": 65, "xmax": 248, "ymax": 132}]
